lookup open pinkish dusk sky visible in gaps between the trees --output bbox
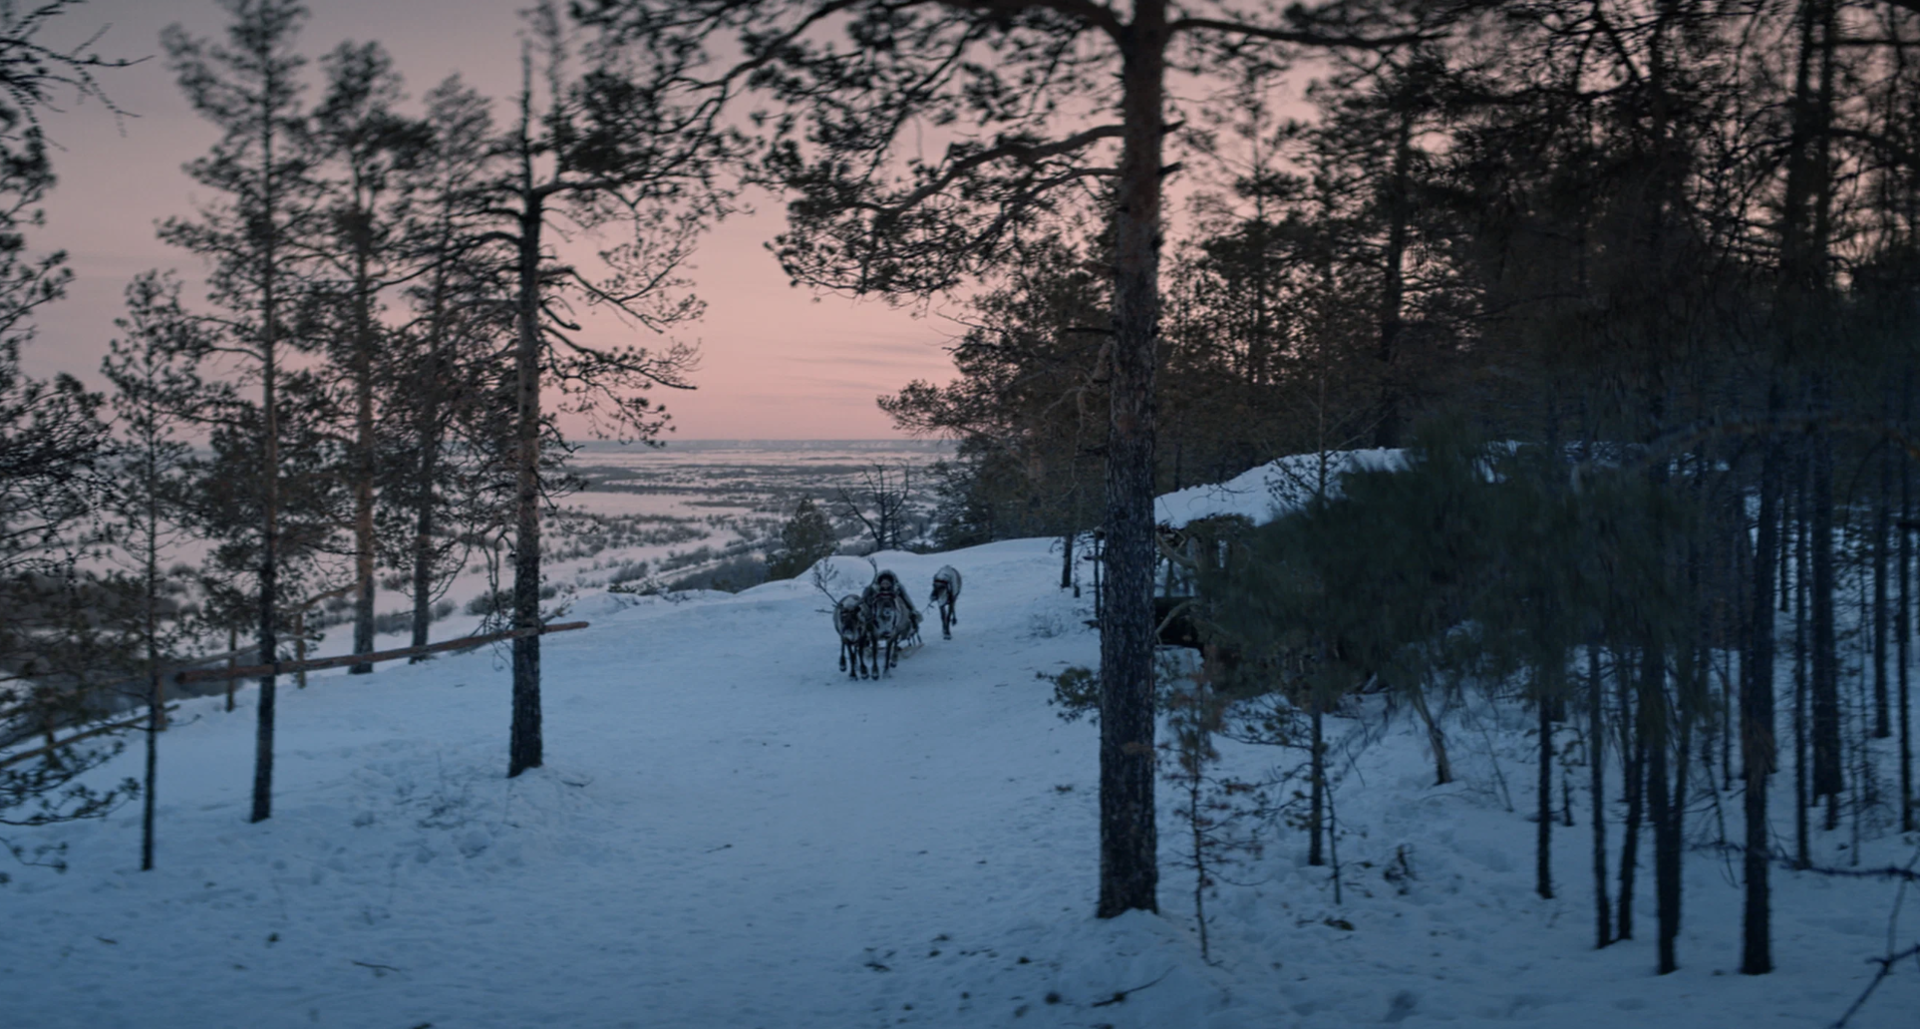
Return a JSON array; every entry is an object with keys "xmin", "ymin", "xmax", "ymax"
[{"xmin": 23, "ymin": 0, "xmax": 958, "ymax": 440}]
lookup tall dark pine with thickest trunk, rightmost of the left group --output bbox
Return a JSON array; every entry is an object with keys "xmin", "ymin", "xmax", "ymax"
[{"xmin": 486, "ymin": 0, "xmax": 728, "ymax": 776}]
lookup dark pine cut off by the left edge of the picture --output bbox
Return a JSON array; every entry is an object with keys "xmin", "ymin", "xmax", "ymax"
[{"xmin": 0, "ymin": 0, "xmax": 138, "ymax": 867}]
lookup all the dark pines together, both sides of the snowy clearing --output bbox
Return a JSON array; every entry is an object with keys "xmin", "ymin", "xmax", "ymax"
[{"xmin": 0, "ymin": 0, "xmax": 1920, "ymax": 973}]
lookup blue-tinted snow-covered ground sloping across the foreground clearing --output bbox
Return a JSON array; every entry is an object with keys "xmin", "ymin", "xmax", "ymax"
[{"xmin": 0, "ymin": 541, "xmax": 1920, "ymax": 1029}]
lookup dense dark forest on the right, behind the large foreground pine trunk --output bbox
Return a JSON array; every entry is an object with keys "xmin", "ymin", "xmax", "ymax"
[{"xmin": 881, "ymin": 0, "xmax": 1920, "ymax": 971}]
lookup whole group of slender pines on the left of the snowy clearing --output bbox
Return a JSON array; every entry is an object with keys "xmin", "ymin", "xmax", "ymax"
[{"xmin": 0, "ymin": 0, "xmax": 730, "ymax": 858}]
